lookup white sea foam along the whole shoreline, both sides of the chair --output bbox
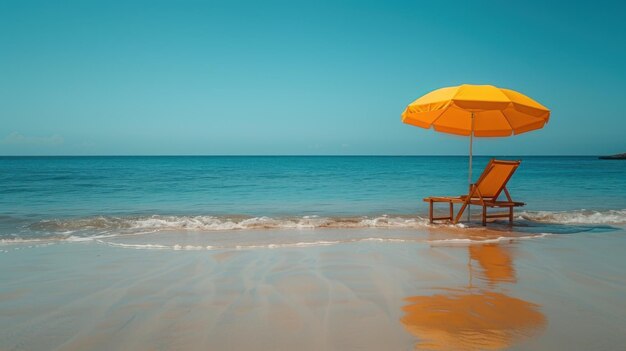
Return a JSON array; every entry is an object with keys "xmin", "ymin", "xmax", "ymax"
[{"xmin": 9, "ymin": 210, "xmax": 626, "ymax": 250}]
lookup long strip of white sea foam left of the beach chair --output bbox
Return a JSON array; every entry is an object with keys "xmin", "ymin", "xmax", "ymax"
[{"xmin": 0, "ymin": 215, "xmax": 434, "ymax": 250}]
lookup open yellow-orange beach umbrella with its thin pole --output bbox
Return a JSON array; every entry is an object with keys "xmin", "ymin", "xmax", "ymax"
[{"xmin": 402, "ymin": 84, "xmax": 550, "ymax": 183}]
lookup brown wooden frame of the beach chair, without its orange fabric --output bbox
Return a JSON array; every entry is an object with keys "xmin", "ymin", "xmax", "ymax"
[{"xmin": 424, "ymin": 159, "xmax": 525, "ymax": 225}]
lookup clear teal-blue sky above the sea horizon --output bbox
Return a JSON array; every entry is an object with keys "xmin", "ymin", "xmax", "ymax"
[{"xmin": 0, "ymin": 0, "xmax": 626, "ymax": 155}]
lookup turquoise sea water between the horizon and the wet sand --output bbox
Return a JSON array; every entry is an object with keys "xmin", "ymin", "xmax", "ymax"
[{"xmin": 0, "ymin": 156, "xmax": 626, "ymax": 241}]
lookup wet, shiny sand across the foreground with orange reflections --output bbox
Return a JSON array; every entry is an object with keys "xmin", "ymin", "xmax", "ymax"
[{"xmin": 0, "ymin": 228, "xmax": 626, "ymax": 350}]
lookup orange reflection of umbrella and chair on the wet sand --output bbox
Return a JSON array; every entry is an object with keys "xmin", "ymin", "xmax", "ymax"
[{"xmin": 401, "ymin": 244, "xmax": 546, "ymax": 350}]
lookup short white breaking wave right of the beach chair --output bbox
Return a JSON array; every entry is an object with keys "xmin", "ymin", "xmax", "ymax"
[{"xmin": 518, "ymin": 209, "xmax": 626, "ymax": 224}]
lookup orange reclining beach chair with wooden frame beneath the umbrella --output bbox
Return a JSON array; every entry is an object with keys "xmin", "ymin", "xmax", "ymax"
[{"xmin": 424, "ymin": 160, "xmax": 525, "ymax": 225}]
